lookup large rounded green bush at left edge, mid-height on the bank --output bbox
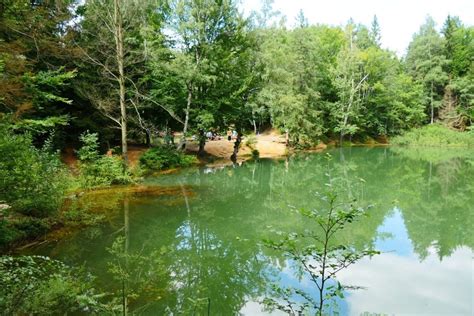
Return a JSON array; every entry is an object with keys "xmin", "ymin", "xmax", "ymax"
[{"xmin": 0, "ymin": 123, "xmax": 69, "ymax": 217}]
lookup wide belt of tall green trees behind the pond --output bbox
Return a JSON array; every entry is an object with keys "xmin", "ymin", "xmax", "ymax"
[{"xmin": 0, "ymin": 0, "xmax": 474, "ymax": 152}]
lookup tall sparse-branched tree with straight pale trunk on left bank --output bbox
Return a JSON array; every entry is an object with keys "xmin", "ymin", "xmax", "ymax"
[{"xmin": 77, "ymin": 0, "xmax": 168, "ymax": 165}]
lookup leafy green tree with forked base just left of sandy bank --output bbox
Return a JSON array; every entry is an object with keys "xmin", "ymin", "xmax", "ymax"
[{"xmin": 165, "ymin": 0, "xmax": 256, "ymax": 153}]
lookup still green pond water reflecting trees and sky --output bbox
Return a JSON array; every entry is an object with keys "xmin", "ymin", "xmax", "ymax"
[{"xmin": 31, "ymin": 148, "xmax": 474, "ymax": 315}]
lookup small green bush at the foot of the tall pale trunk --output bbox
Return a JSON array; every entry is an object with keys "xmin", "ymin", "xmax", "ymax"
[{"xmin": 78, "ymin": 132, "xmax": 132, "ymax": 188}]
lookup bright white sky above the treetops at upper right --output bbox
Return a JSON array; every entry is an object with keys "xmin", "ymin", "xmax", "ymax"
[{"xmin": 241, "ymin": 0, "xmax": 474, "ymax": 56}]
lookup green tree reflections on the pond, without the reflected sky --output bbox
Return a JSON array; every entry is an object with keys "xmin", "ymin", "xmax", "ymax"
[{"xmin": 31, "ymin": 148, "xmax": 474, "ymax": 315}]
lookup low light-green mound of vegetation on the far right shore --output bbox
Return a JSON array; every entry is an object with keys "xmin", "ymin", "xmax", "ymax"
[{"xmin": 391, "ymin": 124, "xmax": 474, "ymax": 147}]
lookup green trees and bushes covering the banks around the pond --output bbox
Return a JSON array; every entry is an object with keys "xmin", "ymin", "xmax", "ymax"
[{"xmin": 0, "ymin": 0, "xmax": 474, "ymax": 313}]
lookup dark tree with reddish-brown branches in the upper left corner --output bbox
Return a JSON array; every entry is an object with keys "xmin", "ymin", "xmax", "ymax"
[{"xmin": 0, "ymin": 0, "xmax": 76, "ymax": 138}]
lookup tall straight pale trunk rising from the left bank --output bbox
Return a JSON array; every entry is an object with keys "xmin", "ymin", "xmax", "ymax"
[{"xmin": 114, "ymin": 0, "xmax": 128, "ymax": 166}]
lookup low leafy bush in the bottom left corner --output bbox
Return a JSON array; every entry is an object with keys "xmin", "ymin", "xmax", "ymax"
[{"xmin": 0, "ymin": 256, "xmax": 104, "ymax": 315}]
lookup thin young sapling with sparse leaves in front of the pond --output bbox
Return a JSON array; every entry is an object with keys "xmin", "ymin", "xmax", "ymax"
[{"xmin": 264, "ymin": 156, "xmax": 379, "ymax": 315}]
